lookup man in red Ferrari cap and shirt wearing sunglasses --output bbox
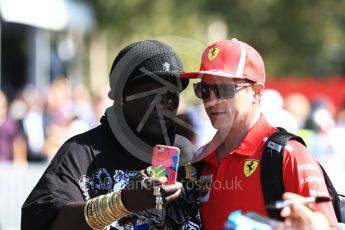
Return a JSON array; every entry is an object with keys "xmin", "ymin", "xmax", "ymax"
[{"xmin": 180, "ymin": 39, "xmax": 339, "ymax": 229}]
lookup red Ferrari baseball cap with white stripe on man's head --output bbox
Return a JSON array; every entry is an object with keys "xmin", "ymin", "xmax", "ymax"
[{"xmin": 180, "ymin": 38, "xmax": 266, "ymax": 83}]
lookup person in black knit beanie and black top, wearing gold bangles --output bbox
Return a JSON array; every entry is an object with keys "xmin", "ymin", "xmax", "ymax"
[{"xmin": 21, "ymin": 40, "xmax": 200, "ymax": 230}]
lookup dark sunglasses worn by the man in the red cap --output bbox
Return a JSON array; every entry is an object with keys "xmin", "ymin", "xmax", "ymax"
[{"xmin": 193, "ymin": 82, "xmax": 253, "ymax": 99}]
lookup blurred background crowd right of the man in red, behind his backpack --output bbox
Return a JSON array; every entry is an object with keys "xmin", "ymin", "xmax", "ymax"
[{"xmin": 262, "ymin": 89, "xmax": 345, "ymax": 193}]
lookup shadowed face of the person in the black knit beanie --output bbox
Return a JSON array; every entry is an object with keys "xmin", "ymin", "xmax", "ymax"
[{"xmin": 123, "ymin": 80, "xmax": 179, "ymax": 145}]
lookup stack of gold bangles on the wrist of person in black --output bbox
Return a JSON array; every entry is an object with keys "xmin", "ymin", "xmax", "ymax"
[{"xmin": 84, "ymin": 190, "xmax": 131, "ymax": 230}]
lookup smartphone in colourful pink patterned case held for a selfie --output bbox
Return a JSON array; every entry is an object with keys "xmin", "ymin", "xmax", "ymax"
[{"xmin": 150, "ymin": 145, "xmax": 180, "ymax": 184}]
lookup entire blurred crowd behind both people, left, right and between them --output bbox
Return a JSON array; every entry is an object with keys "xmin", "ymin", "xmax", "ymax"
[{"xmin": 0, "ymin": 78, "xmax": 345, "ymax": 192}]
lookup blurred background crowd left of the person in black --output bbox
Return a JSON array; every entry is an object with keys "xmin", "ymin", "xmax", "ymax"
[{"xmin": 0, "ymin": 78, "xmax": 111, "ymax": 164}]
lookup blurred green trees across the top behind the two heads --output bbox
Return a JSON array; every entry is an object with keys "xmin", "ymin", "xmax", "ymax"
[{"xmin": 81, "ymin": 0, "xmax": 345, "ymax": 77}]
